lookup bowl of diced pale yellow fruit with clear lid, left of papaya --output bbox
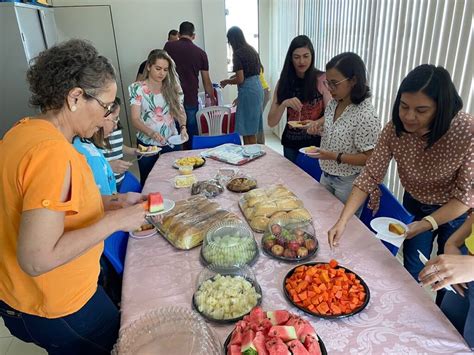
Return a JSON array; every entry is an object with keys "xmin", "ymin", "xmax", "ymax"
[{"xmin": 192, "ymin": 265, "xmax": 262, "ymax": 323}]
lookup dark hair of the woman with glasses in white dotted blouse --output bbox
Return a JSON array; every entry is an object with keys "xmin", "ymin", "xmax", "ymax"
[{"xmin": 326, "ymin": 52, "xmax": 370, "ymax": 105}]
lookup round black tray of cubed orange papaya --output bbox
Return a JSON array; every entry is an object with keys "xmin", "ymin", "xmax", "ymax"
[{"xmin": 285, "ymin": 260, "xmax": 367, "ymax": 316}]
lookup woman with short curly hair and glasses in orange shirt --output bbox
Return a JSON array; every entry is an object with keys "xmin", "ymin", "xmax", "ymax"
[{"xmin": 0, "ymin": 40, "xmax": 145, "ymax": 354}]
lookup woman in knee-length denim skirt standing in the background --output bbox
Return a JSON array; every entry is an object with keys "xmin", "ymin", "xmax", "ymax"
[{"xmin": 220, "ymin": 26, "xmax": 263, "ymax": 144}]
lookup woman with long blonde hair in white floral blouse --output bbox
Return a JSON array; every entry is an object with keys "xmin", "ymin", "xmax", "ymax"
[{"xmin": 128, "ymin": 49, "xmax": 188, "ymax": 186}]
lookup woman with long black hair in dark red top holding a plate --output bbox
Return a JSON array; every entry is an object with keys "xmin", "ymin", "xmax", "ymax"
[{"xmin": 268, "ymin": 35, "xmax": 331, "ymax": 162}]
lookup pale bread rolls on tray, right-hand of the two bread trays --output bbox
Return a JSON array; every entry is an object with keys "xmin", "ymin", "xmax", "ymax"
[{"xmin": 239, "ymin": 184, "xmax": 312, "ymax": 233}]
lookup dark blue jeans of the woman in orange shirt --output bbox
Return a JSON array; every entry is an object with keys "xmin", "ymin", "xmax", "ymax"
[{"xmin": 0, "ymin": 286, "xmax": 120, "ymax": 355}]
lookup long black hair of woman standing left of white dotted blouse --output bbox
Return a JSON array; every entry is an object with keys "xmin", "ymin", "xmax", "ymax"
[{"xmin": 277, "ymin": 35, "xmax": 322, "ymax": 104}]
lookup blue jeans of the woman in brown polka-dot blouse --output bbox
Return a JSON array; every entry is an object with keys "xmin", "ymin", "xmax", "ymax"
[{"xmin": 403, "ymin": 192, "xmax": 467, "ymax": 305}]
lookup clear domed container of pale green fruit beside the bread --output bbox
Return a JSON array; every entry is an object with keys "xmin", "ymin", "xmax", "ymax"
[{"xmin": 201, "ymin": 221, "xmax": 258, "ymax": 267}]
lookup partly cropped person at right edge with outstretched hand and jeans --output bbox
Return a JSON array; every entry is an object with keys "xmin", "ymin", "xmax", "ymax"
[{"xmin": 420, "ymin": 214, "xmax": 474, "ymax": 350}]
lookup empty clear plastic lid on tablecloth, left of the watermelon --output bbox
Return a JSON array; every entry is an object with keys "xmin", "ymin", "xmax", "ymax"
[{"xmin": 112, "ymin": 307, "xmax": 222, "ymax": 355}]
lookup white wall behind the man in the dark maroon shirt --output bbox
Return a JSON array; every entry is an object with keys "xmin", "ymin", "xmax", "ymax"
[{"xmin": 53, "ymin": 0, "xmax": 229, "ymax": 142}]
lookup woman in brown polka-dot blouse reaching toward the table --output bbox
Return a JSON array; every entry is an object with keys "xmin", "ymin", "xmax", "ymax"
[{"xmin": 328, "ymin": 64, "xmax": 474, "ymax": 304}]
